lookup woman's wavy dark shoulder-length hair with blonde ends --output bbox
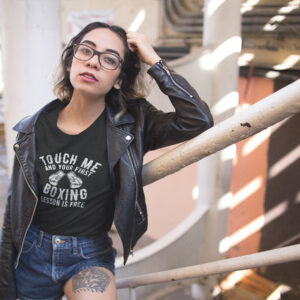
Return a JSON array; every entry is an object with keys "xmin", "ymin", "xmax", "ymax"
[{"xmin": 53, "ymin": 22, "xmax": 147, "ymax": 117}]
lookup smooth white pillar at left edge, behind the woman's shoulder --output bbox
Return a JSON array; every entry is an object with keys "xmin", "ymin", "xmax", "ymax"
[{"xmin": 0, "ymin": 0, "xmax": 61, "ymax": 174}]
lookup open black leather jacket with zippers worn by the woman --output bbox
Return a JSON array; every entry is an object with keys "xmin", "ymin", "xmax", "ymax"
[{"xmin": 0, "ymin": 61, "xmax": 213, "ymax": 300}]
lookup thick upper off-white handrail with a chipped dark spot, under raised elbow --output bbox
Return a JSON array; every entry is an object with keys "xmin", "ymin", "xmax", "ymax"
[{"xmin": 143, "ymin": 79, "xmax": 300, "ymax": 185}]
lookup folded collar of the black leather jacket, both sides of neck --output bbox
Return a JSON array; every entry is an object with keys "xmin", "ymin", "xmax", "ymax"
[{"xmin": 13, "ymin": 99, "xmax": 135, "ymax": 134}]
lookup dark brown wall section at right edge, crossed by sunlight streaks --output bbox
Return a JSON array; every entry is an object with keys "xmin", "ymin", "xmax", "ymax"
[{"xmin": 260, "ymin": 109, "xmax": 300, "ymax": 287}]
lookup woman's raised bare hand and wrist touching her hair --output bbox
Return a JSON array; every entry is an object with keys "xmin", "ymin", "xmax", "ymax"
[{"xmin": 127, "ymin": 31, "xmax": 161, "ymax": 66}]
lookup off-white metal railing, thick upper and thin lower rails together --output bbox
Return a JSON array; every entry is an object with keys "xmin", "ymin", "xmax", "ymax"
[{"xmin": 117, "ymin": 80, "xmax": 300, "ymax": 300}]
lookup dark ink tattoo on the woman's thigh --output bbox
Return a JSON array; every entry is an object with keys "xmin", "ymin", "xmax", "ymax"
[{"xmin": 72, "ymin": 267, "xmax": 111, "ymax": 293}]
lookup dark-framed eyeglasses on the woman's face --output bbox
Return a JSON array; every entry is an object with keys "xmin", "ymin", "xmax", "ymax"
[{"xmin": 73, "ymin": 44, "xmax": 123, "ymax": 70}]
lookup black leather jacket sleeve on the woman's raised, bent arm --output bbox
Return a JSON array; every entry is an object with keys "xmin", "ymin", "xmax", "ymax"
[{"xmin": 144, "ymin": 60, "xmax": 214, "ymax": 152}]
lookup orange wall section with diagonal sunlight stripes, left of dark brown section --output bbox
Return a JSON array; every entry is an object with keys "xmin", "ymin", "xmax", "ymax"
[{"xmin": 226, "ymin": 77, "xmax": 274, "ymax": 257}]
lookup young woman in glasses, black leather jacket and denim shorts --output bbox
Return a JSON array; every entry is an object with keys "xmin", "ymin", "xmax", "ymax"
[{"xmin": 0, "ymin": 22, "xmax": 213, "ymax": 300}]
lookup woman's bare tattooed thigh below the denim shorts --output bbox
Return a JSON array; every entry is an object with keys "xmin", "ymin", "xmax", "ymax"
[{"xmin": 64, "ymin": 266, "xmax": 117, "ymax": 300}]
